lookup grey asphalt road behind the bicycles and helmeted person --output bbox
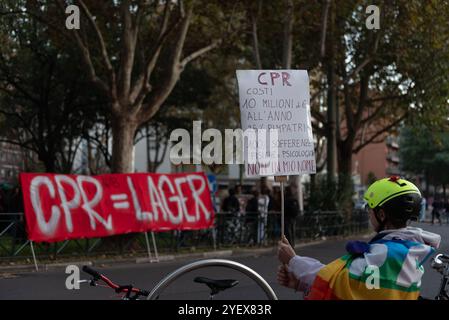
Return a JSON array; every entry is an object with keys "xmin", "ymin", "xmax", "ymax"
[{"xmin": 0, "ymin": 224, "xmax": 449, "ymax": 300}]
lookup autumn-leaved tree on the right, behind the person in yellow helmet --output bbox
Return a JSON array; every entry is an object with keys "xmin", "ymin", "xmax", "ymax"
[{"xmin": 240, "ymin": 0, "xmax": 449, "ymax": 212}]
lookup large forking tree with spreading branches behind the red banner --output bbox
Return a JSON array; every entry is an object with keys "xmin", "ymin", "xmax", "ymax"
[{"xmin": 27, "ymin": 0, "xmax": 242, "ymax": 173}]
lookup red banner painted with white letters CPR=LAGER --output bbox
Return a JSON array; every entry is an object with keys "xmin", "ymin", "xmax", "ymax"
[{"xmin": 20, "ymin": 173, "xmax": 214, "ymax": 242}]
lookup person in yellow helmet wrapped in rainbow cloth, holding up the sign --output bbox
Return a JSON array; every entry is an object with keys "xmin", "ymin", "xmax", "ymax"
[{"xmin": 277, "ymin": 176, "xmax": 441, "ymax": 300}]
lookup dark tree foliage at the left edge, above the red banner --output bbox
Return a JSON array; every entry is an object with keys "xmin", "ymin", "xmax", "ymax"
[{"xmin": 0, "ymin": 1, "xmax": 103, "ymax": 173}]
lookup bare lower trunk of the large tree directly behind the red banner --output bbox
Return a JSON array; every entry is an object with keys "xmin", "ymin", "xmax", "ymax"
[{"xmin": 111, "ymin": 114, "xmax": 137, "ymax": 173}]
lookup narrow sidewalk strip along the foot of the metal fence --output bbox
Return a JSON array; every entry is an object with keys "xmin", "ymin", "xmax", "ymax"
[{"xmin": 0, "ymin": 234, "xmax": 372, "ymax": 274}]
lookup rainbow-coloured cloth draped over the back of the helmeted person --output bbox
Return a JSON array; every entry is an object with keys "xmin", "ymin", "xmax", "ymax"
[{"xmin": 305, "ymin": 227, "xmax": 441, "ymax": 300}]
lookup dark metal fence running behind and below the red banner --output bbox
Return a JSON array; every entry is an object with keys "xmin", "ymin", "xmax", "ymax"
[{"xmin": 0, "ymin": 211, "xmax": 368, "ymax": 261}]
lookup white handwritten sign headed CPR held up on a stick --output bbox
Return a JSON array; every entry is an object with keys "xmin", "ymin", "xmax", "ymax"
[{"xmin": 237, "ymin": 70, "xmax": 316, "ymax": 176}]
